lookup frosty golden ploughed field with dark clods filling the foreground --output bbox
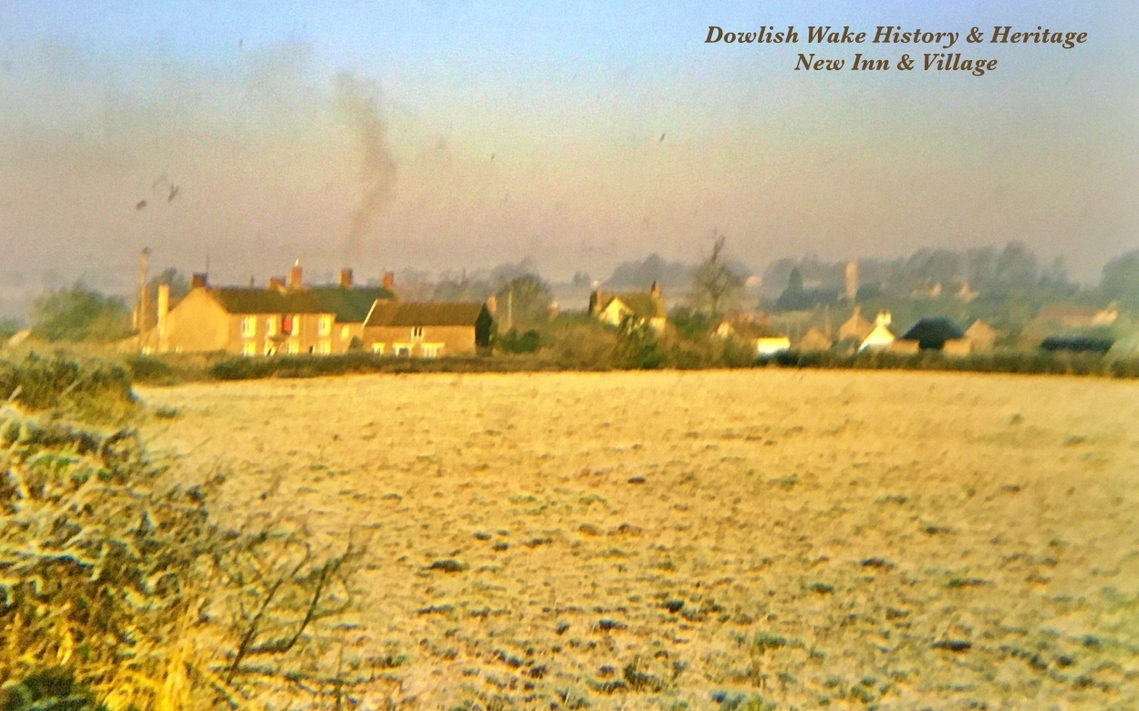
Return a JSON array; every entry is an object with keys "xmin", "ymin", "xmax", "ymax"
[{"xmin": 139, "ymin": 369, "xmax": 1139, "ymax": 709}]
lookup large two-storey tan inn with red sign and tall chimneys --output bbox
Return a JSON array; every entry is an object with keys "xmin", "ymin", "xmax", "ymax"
[{"xmin": 139, "ymin": 267, "xmax": 336, "ymax": 356}]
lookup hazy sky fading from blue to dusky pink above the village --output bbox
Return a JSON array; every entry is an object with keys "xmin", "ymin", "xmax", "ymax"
[{"xmin": 0, "ymin": 0, "xmax": 1139, "ymax": 307}]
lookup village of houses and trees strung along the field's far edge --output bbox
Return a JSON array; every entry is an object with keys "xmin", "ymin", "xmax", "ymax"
[{"xmin": 68, "ymin": 243, "xmax": 1134, "ymax": 359}]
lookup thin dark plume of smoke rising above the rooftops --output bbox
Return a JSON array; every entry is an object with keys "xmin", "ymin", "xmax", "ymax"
[{"xmin": 334, "ymin": 74, "xmax": 398, "ymax": 263}]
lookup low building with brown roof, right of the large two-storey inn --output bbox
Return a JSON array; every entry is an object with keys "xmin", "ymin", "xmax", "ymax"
[{"xmin": 361, "ymin": 300, "xmax": 493, "ymax": 358}]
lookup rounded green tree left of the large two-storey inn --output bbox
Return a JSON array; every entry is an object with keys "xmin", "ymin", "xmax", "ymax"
[{"xmin": 32, "ymin": 283, "xmax": 130, "ymax": 341}]
